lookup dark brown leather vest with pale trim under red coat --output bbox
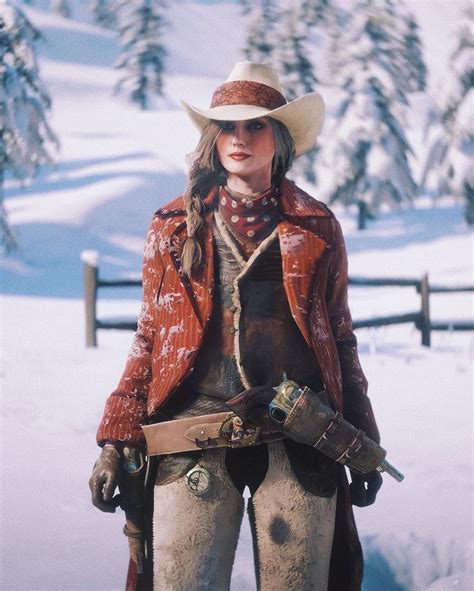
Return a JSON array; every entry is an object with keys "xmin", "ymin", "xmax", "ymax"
[{"xmin": 168, "ymin": 217, "xmax": 322, "ymax": 418}]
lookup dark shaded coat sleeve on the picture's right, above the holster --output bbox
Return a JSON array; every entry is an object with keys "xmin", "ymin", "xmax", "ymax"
[{"xmin": 326, "ymin": 218, "xmax": 380, "ymax": 442}]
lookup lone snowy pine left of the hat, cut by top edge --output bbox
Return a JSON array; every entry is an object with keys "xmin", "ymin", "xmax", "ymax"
[{"xmin": 116, "ymin": 0, "xmax": 166, "ymax": 109}]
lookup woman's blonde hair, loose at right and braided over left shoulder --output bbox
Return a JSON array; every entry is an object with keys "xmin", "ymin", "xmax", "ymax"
[{"xmin": 181, "ymin": 117, "xmax": 295, "ymax": 276}]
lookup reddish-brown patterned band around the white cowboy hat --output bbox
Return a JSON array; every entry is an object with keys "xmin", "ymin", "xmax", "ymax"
[{"xmin": 210, "ymin": 80, "xmax": 287, "ymax": 111}]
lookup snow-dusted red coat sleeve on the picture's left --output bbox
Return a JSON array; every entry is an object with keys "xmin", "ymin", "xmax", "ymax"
[{"xmin": 97, "ymin": 217, "xmax": 164, "ymax": 448}]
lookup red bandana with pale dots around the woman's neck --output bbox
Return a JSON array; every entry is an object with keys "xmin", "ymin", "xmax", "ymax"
[{"xmin": 219, "ymin": 187, "xmax": 278, "ymax": 256}]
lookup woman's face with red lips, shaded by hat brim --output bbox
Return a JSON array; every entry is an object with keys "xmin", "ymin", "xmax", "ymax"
[{"xmin": 216, "ymin": 117, "xmax": 275, "ymax": 187}]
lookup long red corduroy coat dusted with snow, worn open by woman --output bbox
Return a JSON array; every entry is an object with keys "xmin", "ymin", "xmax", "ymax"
[{"xmin": 97, "ymin": 180, "xmax": 379, "ymax": 591}]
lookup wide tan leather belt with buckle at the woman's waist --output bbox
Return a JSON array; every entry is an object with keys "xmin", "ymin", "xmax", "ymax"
[{"xmin": 142, "ymin": 412, "xmax": 285, "ymax": 456}]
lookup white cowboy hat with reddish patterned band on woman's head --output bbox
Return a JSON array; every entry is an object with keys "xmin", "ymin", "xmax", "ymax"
[{"xmin": 181, "ymin": 61, "xmax": 324, "ymax": 156}]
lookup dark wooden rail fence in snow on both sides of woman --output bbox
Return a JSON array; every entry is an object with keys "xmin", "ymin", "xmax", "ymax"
[{"xmin": 81, "ymin": 252, "xmax": 474, "ymax": 347}]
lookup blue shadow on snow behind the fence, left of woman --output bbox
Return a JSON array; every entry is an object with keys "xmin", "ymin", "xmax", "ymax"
[{"xmin": 2, "ymin": 164, "xmax": 186, "ymax": 299}]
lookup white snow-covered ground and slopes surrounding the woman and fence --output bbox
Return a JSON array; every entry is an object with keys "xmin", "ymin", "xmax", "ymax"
[{"xmin": 0, "ymin": 1, "xmax": 474, "ymax": 591}]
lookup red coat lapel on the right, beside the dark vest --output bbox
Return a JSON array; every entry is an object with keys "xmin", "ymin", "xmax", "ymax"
[{"xmin": 278, "ymin": 220, "xmax": 327, "ymax": 347}]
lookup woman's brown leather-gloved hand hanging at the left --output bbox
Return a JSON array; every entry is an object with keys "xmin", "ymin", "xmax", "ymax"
[{"xmin": 89, "ymin": 443, "xmax": 122, "ymax": 513}]
